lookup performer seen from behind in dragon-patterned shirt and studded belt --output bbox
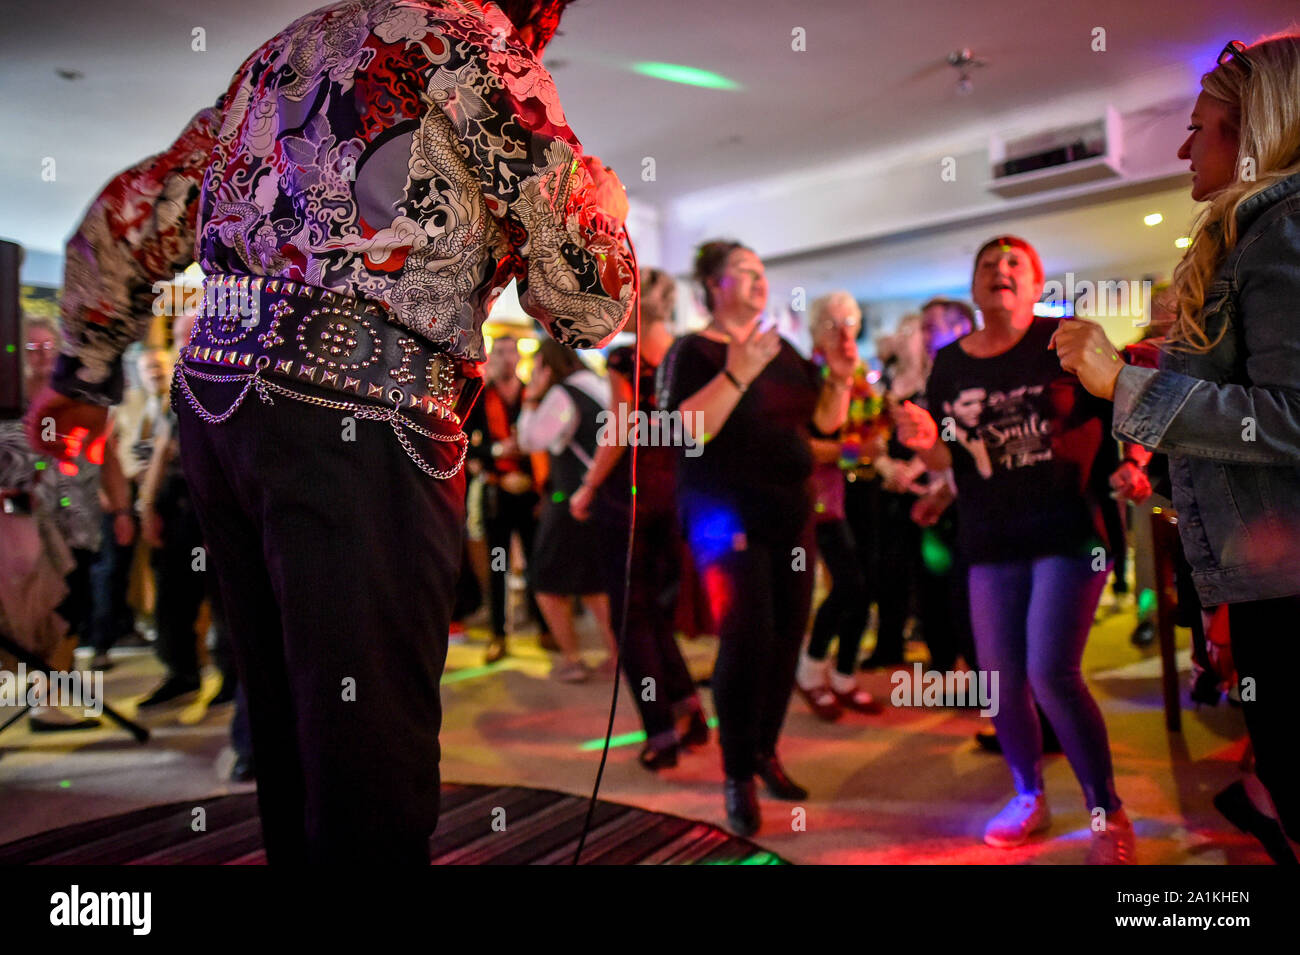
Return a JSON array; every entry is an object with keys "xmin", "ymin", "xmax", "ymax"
[{"xmin": 26, "ymin": 0, "xmax": 634, "ymax": 864}]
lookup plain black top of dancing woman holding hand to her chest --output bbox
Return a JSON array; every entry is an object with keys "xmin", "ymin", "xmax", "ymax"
[{"xmin": 658, "ymin": 335, "xmax": 822, "ymax": 541}]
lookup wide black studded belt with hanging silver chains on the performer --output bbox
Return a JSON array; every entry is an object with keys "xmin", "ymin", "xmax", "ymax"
[{"xmin": 176, "ymin": 275, "xmax": 482, "ymax": 477}]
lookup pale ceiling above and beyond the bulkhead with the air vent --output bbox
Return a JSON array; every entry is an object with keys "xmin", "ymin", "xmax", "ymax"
[{"xmin": 0, "ymin": 0, "xmax": 1300, "ymax": 291}]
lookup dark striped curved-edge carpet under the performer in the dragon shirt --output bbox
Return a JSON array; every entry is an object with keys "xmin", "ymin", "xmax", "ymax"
[{"xmin": 0, "ymin": 783, "xmax": 784, "ymax": 865}]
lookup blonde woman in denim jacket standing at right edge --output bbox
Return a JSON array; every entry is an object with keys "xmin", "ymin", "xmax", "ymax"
[{"xmin": 1056, "ymin": 34, "xmax": 1300, "ymax": 863}]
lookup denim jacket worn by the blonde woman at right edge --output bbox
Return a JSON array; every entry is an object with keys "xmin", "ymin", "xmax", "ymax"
[{"xmin": 1114, "ymin": 174, "xmax": 1300, "ymax": 605}]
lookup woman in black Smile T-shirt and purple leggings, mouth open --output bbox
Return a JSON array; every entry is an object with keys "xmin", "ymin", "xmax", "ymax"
[{"xmin": 896, "ymin": 236, "xmax": 1134, "ymax": 863}]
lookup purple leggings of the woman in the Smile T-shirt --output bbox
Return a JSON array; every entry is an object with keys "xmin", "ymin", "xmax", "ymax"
[{"xmin": 970, "ymin": 555, "xmax": 1119, "ymax": 812}]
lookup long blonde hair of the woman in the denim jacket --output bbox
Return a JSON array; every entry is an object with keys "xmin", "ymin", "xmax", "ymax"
[{"xmin": 1169, "ymin": 34, "xmax": 1300, "ymax": 352}]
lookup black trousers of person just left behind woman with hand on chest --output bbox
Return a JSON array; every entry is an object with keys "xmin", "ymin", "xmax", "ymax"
[{"xmin": 603, "ymin": 512, "xmax": 696, "ymax": 747}]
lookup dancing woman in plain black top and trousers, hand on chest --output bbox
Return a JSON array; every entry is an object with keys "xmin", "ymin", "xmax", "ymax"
[{"xmin": 659, "ymin": 242, "xmax": 857, "ymax": 835}]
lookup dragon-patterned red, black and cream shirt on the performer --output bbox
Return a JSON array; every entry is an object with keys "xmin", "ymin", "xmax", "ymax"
[{"xmin": 55, "ymin": 0, "xmax": 634, "ymax": 404}]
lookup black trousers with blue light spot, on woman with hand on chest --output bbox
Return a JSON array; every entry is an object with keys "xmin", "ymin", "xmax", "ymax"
[{"xmin": 686, "ymin": 513, "xmax": 815, "ymax": 780}]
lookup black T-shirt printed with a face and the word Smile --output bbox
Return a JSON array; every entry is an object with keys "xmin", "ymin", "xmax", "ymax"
[{"xmin": 927, "ymin": 320, "xmax": 1118, "ymax": 564}]
